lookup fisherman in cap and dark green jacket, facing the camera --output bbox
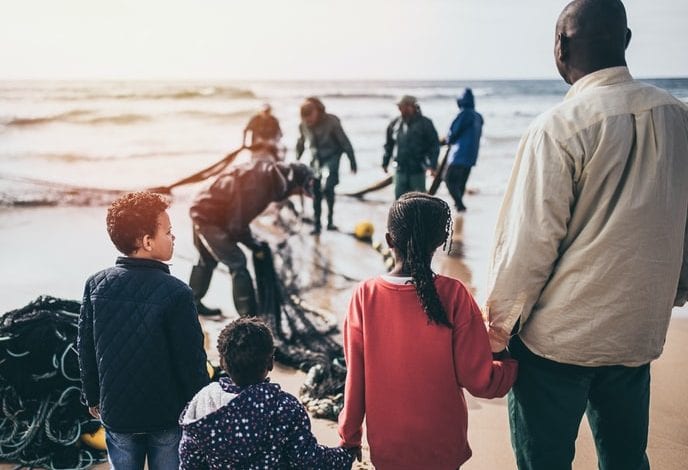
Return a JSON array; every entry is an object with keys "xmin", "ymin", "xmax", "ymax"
[{"xmin": 382, "ymin": 95, "xmax": 440, "ymax": 199}]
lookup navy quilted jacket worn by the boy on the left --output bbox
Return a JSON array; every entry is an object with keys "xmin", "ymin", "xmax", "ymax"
[{"xmin": 78, "ymin": 257, "xmax": 208, "ymax": 433}]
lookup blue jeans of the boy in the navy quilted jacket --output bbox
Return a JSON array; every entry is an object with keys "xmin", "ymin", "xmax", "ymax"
[{"xmin": 105, "ymin": 427, "xmax": 182, "ymax": 470}]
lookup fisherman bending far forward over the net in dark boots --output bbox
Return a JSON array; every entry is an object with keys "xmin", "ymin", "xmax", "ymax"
[{"xmin": 189, "ymin": 156, "xmax": 313, "ymax": 316}]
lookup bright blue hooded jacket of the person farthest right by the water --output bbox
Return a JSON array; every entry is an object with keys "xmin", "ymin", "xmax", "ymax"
[{"xmin": 447, "ymin": 88, "xmax": 483, "ymax": 167}]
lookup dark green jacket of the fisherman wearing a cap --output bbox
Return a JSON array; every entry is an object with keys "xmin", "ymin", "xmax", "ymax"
[{"xmin": 382, "ymin": 108, "xmax": 440, "ymax": 174}]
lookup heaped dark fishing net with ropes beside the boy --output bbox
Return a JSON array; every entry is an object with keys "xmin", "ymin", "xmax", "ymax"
[{"xmin": 0, "ymin": 296, "xmax": 105, "ymax": 469}]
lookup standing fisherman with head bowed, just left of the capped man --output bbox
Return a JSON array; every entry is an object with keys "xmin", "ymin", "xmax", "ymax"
[{"xmin": 296, "ymin": 97, "xmax": 356, "ymax": 235}]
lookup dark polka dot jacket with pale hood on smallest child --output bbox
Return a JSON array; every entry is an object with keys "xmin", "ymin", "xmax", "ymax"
[{"xmin": 179, "ymin": 377, "xmax": 353, "ymax": 470}]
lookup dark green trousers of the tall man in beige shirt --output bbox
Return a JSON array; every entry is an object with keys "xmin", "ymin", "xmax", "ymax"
[{"xmin": 509, "ymin": 337, "xmax": 650, "ymax": 470}]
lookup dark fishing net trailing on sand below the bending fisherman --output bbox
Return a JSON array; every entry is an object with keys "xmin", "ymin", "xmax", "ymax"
[{"xmin": 253, "ymin": 242, "xmax": 346, "ymax": 421}]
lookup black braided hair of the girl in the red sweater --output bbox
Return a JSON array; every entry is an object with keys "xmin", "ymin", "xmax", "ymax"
[{"xmin": 387, "ymin": 192, "xmax": 452, "ymax": 328}]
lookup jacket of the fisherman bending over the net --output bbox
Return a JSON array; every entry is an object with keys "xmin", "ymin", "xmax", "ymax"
[{"xmin": 189, "ymin": 158, "xmax": 295, "ymax": 241}]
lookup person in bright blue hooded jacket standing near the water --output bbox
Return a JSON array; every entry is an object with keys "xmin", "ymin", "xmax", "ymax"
[{"xmin": 444, "ymin": 88, "xmax": 483, "ymax": 212}]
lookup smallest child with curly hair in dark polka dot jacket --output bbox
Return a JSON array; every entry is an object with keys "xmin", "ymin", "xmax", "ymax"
[{"xmin": 179, "ymin": 318, "xmax": 360, "ymax": 470}]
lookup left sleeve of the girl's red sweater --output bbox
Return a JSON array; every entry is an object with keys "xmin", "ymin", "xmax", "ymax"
[{"xmin": 339, "ymin": 287, "xmax": 365, "ymax": 447}]
